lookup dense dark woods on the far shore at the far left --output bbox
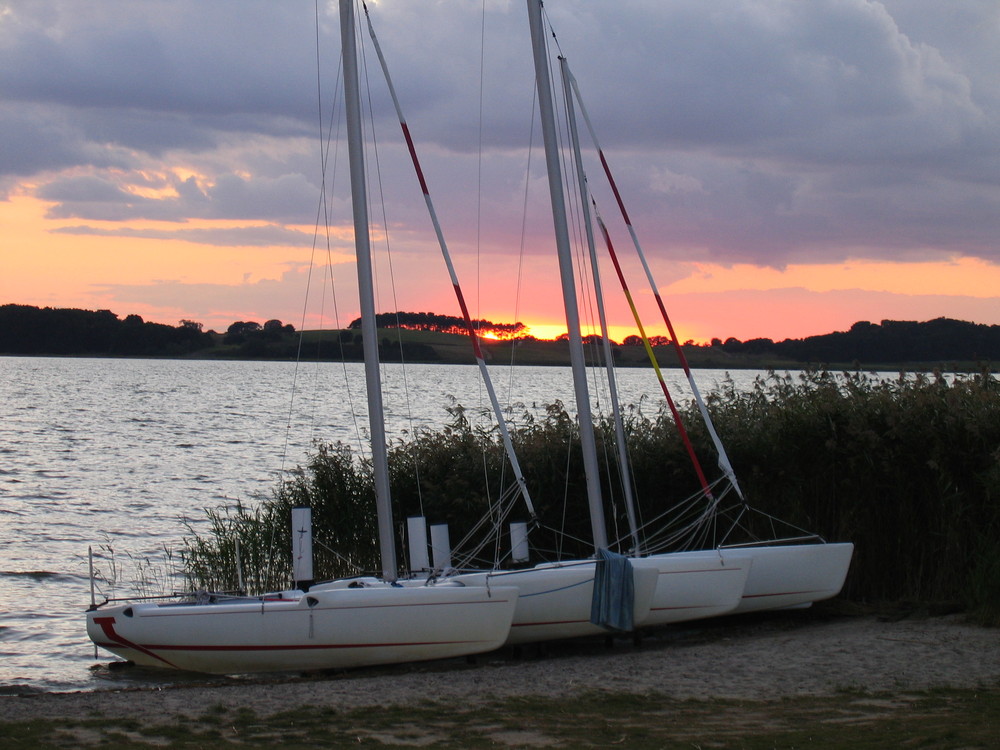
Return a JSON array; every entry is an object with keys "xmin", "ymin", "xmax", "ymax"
[{"xmin": 0, "ymin": 305, "xmax": 215, "ymax": 356}]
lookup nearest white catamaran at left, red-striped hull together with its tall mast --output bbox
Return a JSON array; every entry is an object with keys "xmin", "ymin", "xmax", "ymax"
[{"xmin": 87, "ymin": 0, "xmax": 518, "ymax": 674}]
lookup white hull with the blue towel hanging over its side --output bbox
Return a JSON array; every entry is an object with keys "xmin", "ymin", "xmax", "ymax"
[{"xmin": 454, "ymin": 560, "xmax": 657, "ymax": 645}]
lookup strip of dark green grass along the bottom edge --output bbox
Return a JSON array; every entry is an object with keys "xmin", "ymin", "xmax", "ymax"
[{"xmin": 0, "ymin": 692, "xmax": 1000, "ymax": 750}]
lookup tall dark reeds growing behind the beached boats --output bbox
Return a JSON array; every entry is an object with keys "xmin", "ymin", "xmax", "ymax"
[{"xmin": 183, "ymin": 370, "xmax": 1000, "ymax": 622}]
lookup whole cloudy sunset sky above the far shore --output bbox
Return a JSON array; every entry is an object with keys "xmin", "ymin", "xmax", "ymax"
[{"xmin": 0, "ymin": 0, "xmax": 1000, "ymax": 341}]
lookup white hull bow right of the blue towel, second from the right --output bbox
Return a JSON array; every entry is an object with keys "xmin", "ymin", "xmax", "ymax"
[{"xmin": 632, "ymin": 550, "xmax": 751, "ymax": 627}]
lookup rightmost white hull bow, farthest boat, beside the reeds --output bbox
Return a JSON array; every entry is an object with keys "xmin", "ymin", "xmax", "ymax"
[{"xmin": 721, "ymin": 542, "xmax": 854, "ymax": 612}]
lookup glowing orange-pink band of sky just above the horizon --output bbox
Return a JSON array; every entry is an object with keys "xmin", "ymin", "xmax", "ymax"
[{"xmin": 7, "ymin": 196, "xmax": 1000, "ymax": 343}]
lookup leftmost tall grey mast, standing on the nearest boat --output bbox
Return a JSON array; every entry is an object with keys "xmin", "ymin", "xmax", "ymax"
[{"xmin": 340, "ymin": 0, "xmax": 396, "ymax": 582}]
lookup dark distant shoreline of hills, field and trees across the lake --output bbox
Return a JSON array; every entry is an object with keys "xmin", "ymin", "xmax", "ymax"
[{"xmin": 0, "ymin": 304, "xmax": 1000, "ymax": 369}]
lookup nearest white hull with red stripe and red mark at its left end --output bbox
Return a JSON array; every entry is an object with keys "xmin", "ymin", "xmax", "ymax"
[{"xmin": 87, "ymin": 584, "xmax": 518, "ymax": 674}]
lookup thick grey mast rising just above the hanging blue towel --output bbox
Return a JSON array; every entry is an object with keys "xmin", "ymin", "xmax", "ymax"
[{"xmin": 528, "ymin": 0, "xmax": 608, "ymax": 550}]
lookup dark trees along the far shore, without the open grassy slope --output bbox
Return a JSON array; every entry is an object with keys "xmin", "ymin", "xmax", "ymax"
[{"xmin": 0, "ymin": 304, "xmax": 1000, "ymax": 364}]
